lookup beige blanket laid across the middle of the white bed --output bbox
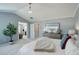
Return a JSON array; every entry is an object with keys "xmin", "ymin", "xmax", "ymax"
[{"xmin": 34, "ymin": 38, "xmax": 55, "ymax": 52}]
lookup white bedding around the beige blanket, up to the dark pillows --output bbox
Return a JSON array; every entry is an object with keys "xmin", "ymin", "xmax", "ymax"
[{"xmin": 17, "ymin": 37, "xmax": 64, "ymax": 55}]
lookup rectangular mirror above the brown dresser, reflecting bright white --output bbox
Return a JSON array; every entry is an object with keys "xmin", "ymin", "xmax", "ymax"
[{"xmin": 43, "ymin": 23, "xmax": 60, "ymax": 33}]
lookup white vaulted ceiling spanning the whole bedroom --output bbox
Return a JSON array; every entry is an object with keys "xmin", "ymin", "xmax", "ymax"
[{"xmin": 0, "ymin": 3, "xmax": 78, "ymax": 21}]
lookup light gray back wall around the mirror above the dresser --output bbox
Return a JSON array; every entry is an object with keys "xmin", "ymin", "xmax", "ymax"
[{"xmin": 39, "ymin": 17, "xmax": 74, "ymax": 36}]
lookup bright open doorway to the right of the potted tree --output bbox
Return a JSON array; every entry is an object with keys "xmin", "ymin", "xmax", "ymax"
[{"xmin": 18, "ymin": 22, "xmax": 28, "ymax": 39}]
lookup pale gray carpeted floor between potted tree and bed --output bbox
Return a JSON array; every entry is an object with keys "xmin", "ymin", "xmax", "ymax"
[{"xmin": 0, "ymin": 39, "xmax": 32, "ymax": 55}]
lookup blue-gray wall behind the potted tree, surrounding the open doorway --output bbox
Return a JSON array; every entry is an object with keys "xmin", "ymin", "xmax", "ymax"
[{"xmin": 0, "ymin": 12, "xmax": 30, "ymax": 43}]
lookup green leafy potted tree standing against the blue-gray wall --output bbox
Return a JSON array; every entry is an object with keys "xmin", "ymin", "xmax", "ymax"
[{"xmin": 3, "ymin": 23, "xmax": 17, "ymax": 43}]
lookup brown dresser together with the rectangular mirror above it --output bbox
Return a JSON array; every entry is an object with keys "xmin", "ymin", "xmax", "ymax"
[{"xmin": 43, "ymin": 23, "xmax": 62, "ymax": 39}]
